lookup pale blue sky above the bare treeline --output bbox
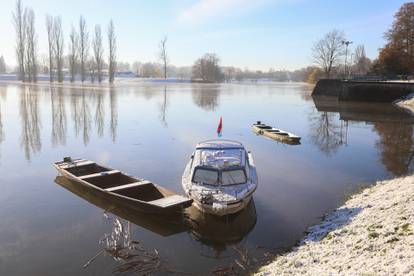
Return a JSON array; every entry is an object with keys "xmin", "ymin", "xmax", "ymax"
[{"xmin": 0, "ymin": 0, "xmax": 407, "ymax": 70}]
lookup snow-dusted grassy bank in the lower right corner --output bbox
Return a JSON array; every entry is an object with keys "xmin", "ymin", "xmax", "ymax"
[{"xmin": 258, "ymin": 175, "xmax": 414, "ymax": 275}]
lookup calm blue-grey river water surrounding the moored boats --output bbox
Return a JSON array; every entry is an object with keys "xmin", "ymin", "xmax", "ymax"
[{"xmin": 0, "ymin": 84, "xmax": 414, "ymax": 275}]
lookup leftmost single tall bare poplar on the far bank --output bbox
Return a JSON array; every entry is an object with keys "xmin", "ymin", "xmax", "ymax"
[{"xmin": 13, "ymin": 0, "xmax": 26, "ymax": 81}]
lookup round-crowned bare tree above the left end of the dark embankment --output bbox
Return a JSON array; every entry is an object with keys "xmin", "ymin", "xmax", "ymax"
[{"xmin": 312, "ymin": 30, "xmax": 345, "ymax": 78}]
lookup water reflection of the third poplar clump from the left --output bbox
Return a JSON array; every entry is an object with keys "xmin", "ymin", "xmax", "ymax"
[{"xmin": 71, "ymin": 90, "xmax": 91, "ymax": 145}]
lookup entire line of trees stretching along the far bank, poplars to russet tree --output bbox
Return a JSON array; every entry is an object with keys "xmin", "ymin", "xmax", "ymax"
[{"xmin": 8, "ymin": 0, "xmax": 414, "ymax": 83}]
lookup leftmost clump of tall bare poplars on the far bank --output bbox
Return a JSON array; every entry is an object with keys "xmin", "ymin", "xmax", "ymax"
[{"xmin": 13, "ymin": 0, "xmax": 38, "ymax": 82}]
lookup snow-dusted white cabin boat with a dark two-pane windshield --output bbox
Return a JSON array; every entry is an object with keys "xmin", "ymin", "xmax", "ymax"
[{"xmin": 182, "ymin": 139, "xmax": 258, "ymax": 216}]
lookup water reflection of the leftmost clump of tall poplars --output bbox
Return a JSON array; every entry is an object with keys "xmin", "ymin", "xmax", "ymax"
[{"xmin": 20, "ymin": 87, "xmax": 42, "ymax": 160}]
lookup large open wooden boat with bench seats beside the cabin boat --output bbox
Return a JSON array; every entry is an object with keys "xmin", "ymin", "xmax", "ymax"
[{"xmin": 53, "ymin": 157, "xmax": 192, "ymax": 214}]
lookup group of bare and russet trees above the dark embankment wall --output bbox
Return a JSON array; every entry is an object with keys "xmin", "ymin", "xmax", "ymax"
[{"xmin": 309, "ymin": 2, "xmax": 414, "ymax": 80}]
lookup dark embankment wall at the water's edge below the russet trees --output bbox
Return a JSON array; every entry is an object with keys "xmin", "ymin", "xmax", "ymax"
[{"xmin": 312, "ymin": 79, "xmax": 414, "ymax": 102}]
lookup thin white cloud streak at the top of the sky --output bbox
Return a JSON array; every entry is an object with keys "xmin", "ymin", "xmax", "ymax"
[{"xmin": 178, "ymin": 0, "xmax": 268, "ymax": 24}]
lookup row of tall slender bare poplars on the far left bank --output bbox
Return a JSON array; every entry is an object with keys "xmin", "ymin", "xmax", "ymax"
[{"xmin": 12, "ymin": 0, "xmax": 117, "ymax": 83}]
